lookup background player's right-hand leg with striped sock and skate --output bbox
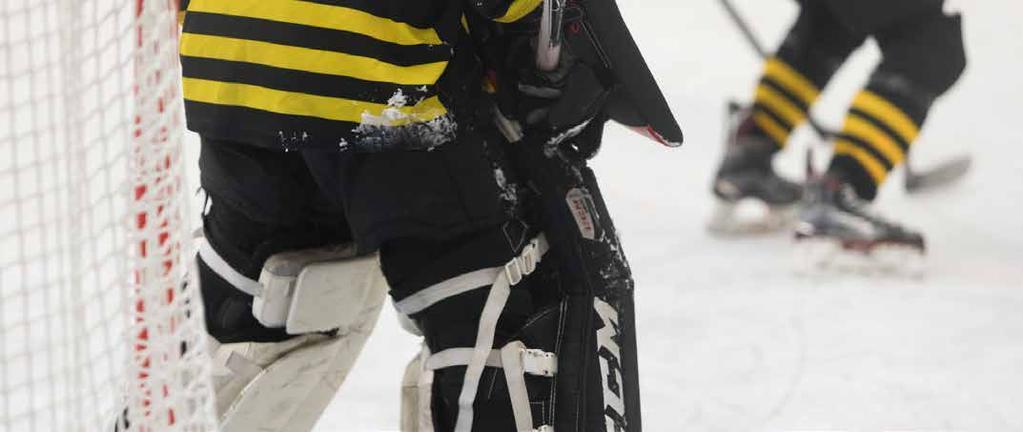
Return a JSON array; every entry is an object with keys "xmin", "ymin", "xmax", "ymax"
[{"xmin": 797, "ymin": 0, "xmax": 966, "ymax": 269}]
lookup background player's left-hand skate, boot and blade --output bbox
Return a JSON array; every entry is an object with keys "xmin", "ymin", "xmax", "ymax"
[{"xmin": 707, "ymin": 103, "xmax": 803, "ymax": 235}]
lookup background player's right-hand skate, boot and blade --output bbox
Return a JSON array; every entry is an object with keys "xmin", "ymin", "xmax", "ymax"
[{"xmin": 795, "ymin": 171, "xmax": 927, "ymax": 275}]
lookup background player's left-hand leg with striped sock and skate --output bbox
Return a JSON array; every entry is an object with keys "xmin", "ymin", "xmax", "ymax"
[{"xmin": 710, "ymin": 1, "xmax": 866, "ymax": 233}]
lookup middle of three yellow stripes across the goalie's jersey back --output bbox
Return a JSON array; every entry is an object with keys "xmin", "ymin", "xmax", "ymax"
[{"xmin": 181, "ymin": 33, "xmax": 447, "ymax": 85}]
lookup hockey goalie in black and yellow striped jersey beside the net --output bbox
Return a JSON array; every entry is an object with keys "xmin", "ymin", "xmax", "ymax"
[{"xmin": 174, "ymin": 0, "xmax": 681, "ymax": 432}]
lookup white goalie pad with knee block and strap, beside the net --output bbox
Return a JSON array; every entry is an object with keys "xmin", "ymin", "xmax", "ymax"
[{"xmin": 201, "ymin": 242, "xmax": 387, "ymax": 432}]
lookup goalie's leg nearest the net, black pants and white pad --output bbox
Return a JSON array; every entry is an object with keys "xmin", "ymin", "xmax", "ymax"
[{"xmin": 197, "ymin": 139, "xmax": 384, "ymax": 431}]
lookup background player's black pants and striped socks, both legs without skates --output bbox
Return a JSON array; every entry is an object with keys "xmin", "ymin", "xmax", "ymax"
[{"xmin": 759, "ymin": 0, "xmax": 966, "ymax": 200}]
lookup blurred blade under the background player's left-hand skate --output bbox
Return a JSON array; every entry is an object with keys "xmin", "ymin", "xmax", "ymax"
[{"xmin": 707, "ymin": 199, "xmax": 797, "ymax": 236}]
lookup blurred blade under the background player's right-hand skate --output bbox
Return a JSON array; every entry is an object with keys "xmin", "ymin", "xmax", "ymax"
[{"xmin": 793, "ymin": 239, "xmax": 927, "ymax": 279}]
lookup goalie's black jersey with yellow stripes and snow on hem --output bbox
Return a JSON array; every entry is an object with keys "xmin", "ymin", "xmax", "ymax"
[{"xmin": 180, "ymin": 0, "xmax": 542, "ymax": 148}]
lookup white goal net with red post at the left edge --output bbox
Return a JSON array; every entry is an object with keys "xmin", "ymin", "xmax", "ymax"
[{"xmin": 0, "ymin": 0, "xmax": 216, "ymax": 432}]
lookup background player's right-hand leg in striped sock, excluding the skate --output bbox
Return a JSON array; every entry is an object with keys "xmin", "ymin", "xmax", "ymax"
[{"xmin": 829, "ymin": 0, "xmax": 966, "ymax": 201}]
